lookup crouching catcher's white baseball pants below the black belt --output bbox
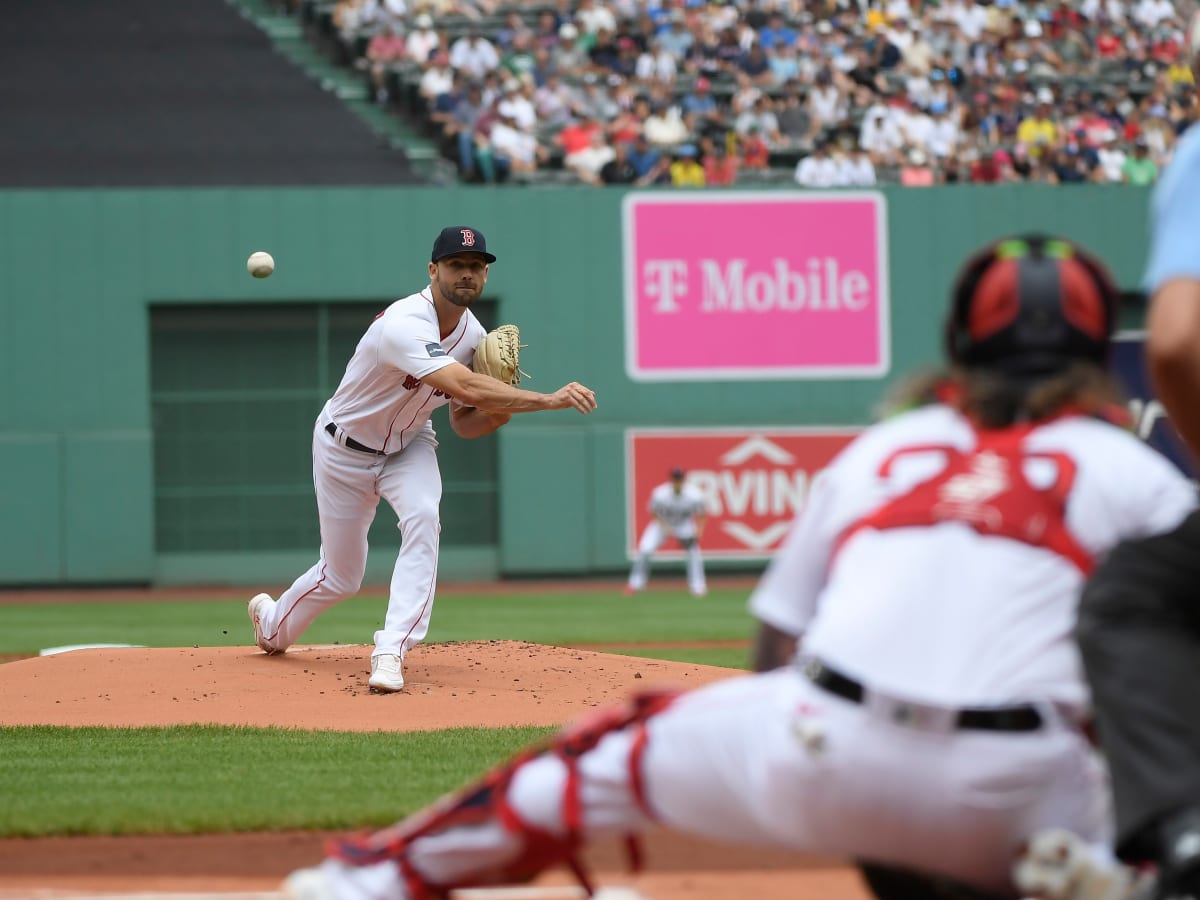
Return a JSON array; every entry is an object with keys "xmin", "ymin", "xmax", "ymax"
[{"xmin": 307, "ymin": 667, "xmax": 1111, "ymax": 900}]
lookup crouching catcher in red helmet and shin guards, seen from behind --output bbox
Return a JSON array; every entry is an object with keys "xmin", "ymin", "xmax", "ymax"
[{"xmin": 278, "ymin": 235, "xmax": 1196, "ymax": 900}]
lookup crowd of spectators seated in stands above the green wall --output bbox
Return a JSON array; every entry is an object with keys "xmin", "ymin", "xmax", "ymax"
[{"xmin": 294, "ymin": 0, "xmax": 1194, "ymax": 187}]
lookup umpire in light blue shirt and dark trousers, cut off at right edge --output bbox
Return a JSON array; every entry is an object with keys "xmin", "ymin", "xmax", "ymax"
[{"xmin": 1079, "ymin": 18, "xmax": 1200, "ymax": 900}]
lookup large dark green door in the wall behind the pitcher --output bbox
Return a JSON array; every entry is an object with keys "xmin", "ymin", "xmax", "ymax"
[{"xmin": 150, "ymin": 301, "xmax": 498, "ymax": 554}]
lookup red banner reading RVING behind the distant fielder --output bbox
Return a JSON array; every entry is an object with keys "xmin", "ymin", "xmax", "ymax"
[{"xmin": 625, "ymin": 428, "xmax": 858, "ymax": 559}]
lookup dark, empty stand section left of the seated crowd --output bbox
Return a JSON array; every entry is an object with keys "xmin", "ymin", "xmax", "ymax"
[{"xmin": 0, "ymin": 0, "xmax": 418, "ymax": 187}]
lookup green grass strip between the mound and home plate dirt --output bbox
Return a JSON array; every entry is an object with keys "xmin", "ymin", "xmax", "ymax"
[{"xmin": 0, "ymin": 726, "xmax": 551, "ymax": 838}]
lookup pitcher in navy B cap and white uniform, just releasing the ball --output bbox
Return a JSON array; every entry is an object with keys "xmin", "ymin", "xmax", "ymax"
[{"xmin": 248, "ymin": 226, "xmax": 596, "ymax": 692}]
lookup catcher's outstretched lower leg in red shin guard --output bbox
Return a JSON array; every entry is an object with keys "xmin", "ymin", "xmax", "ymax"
[{"xmin": 330, "ymin": 691, "xmax": 678, "ymax": 900}]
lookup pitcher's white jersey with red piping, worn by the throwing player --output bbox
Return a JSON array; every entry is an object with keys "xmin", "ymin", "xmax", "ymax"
[{"xmin": 324, "ymin": 288, "xmax": 487, "ymax": 454}]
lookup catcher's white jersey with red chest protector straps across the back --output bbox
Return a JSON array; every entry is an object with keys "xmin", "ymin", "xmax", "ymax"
[{"xmin": 750, "ymin": 407, "xmax": 1196, "ymax": 714}]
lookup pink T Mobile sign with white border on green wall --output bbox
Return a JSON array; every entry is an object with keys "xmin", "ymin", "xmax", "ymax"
[{"xmin": 623, "ymin": 192, "xmax": 889, "ymax": 382}]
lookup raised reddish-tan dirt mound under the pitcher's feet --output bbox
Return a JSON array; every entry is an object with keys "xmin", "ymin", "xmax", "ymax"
[{"xmin": 0, "ymin": 641, "xmax": 737, "ymax": 731}]
